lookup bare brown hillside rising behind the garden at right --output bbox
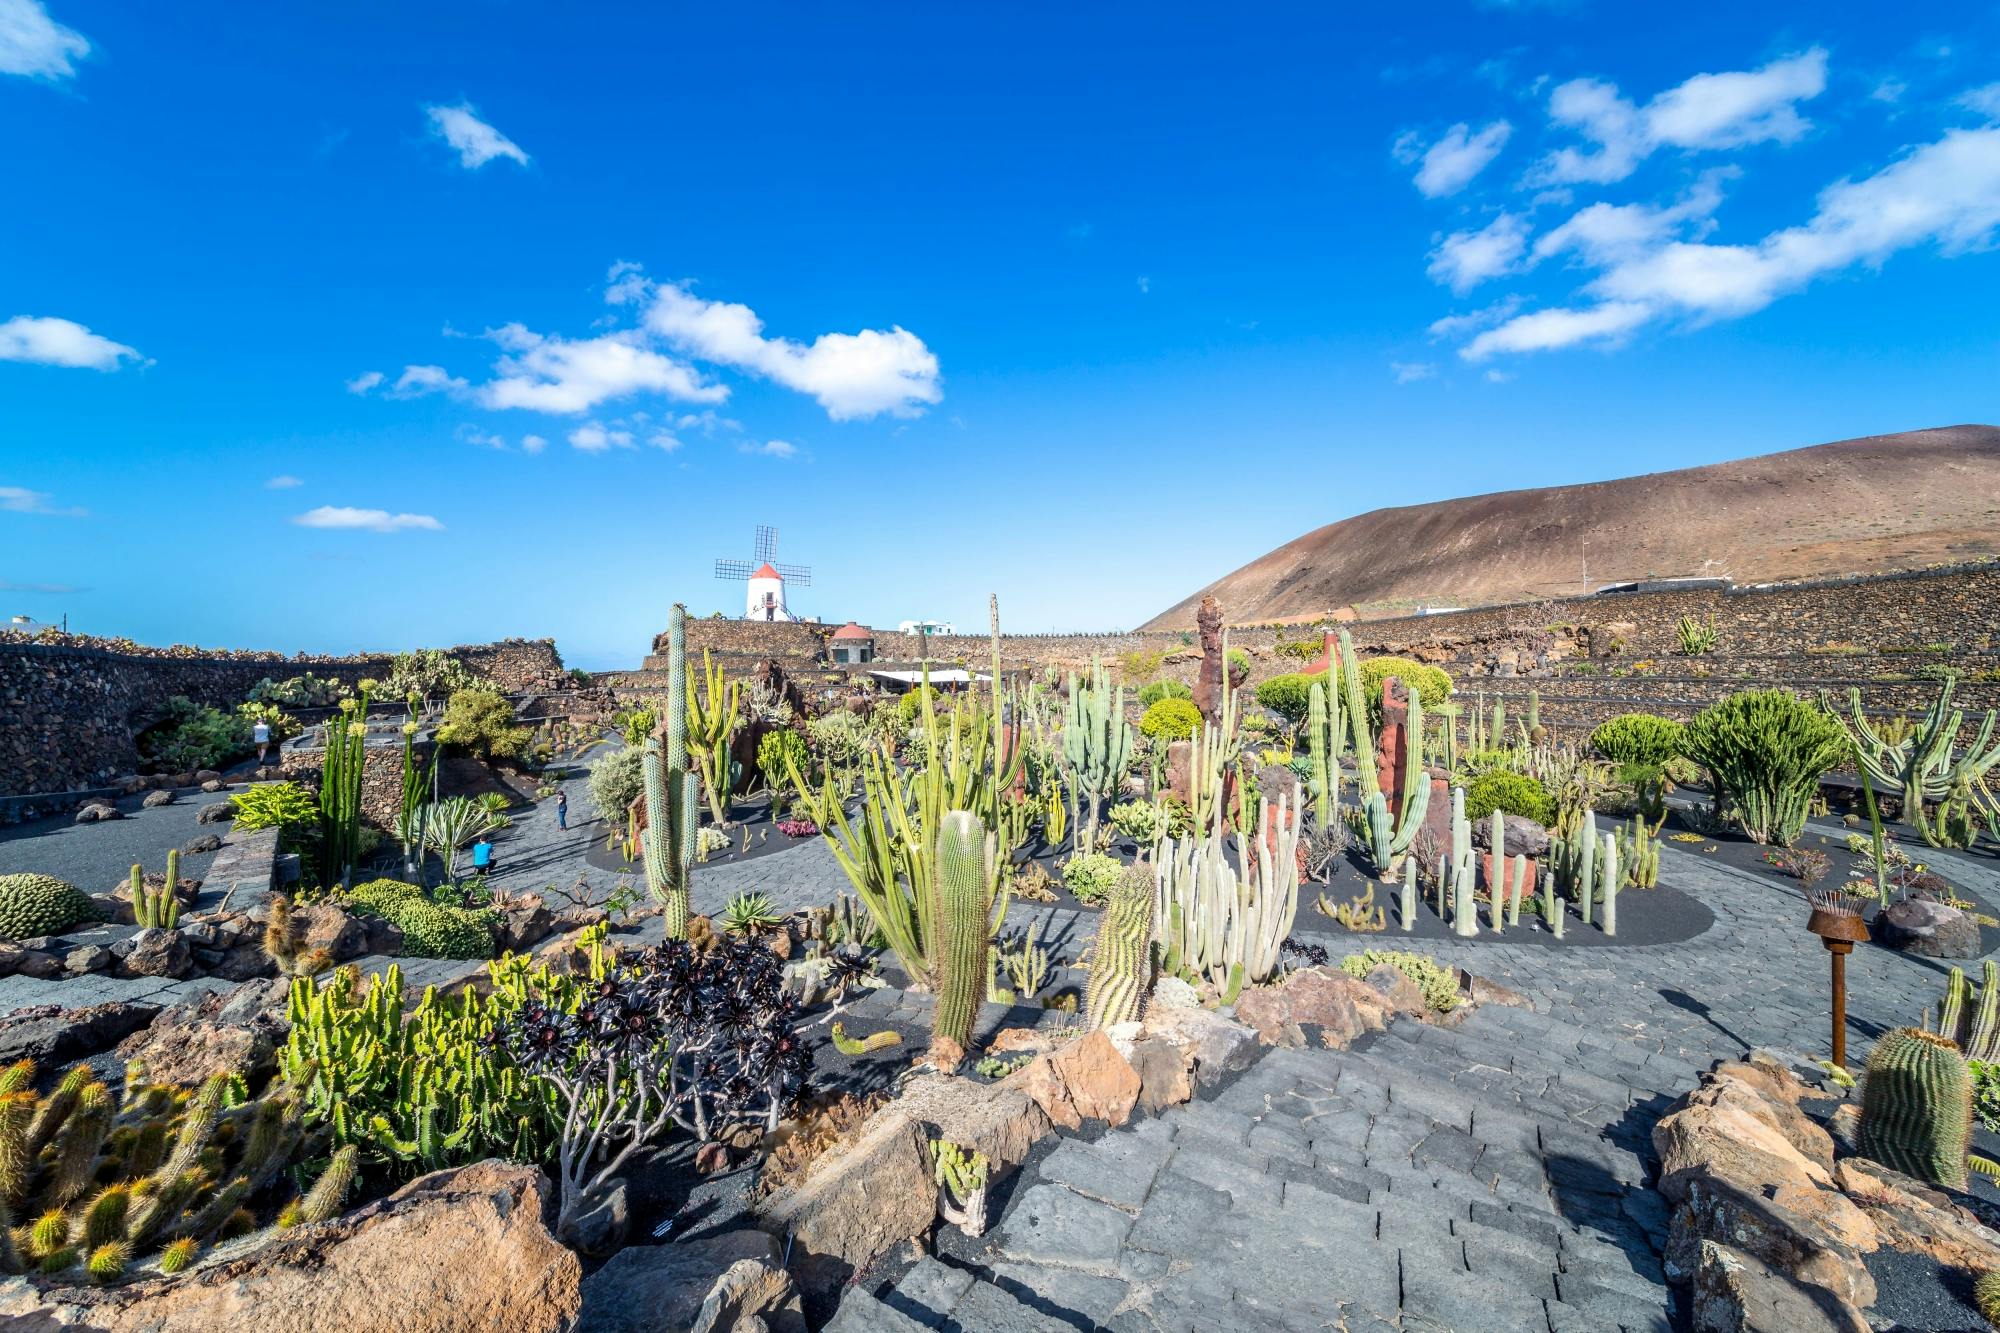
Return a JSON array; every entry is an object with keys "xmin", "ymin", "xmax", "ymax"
[{"xmin": 1140, "ymin": 426, "xmax": 2000, "ymax": 628}]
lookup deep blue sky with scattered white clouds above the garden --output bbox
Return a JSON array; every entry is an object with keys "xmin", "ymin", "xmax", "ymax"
[{"xmin": 0, "ymin": 0, "xmax": 2000, "ymax": 667}]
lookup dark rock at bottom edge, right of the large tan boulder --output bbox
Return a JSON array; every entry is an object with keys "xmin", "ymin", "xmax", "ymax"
[{"xmin": 582, "ymin": 1231, "xmax": 806, "ymax": 1333}]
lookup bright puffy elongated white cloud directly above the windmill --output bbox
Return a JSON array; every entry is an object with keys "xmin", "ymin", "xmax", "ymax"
[{"xmin": 646, "ymin": 270, "xmax": 944, "ymax": 420}]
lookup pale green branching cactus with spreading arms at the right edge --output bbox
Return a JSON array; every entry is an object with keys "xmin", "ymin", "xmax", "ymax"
[{"xmin": 1822, "ymin": 677, "xmax": 2000, "ymax": 847}]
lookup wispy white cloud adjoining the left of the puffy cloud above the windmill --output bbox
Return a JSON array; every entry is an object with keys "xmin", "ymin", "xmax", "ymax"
[{"xmin": 480, "ymin": 324, "xmax": 730, "ymax": 414}]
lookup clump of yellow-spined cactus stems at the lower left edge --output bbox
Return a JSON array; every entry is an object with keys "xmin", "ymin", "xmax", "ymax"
[{"xmin": 0, "ymin": 1061, "xmax": 352, "ymax": 1283}]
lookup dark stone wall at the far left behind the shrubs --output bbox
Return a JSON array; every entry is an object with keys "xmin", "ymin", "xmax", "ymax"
[{"xmin": 0, "ymin": 632, "xmax": 574, "ymax": 797}]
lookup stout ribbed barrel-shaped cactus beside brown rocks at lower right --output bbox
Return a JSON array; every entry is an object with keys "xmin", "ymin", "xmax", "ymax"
[{"xmin": 1860, "ymin": 1027, "xmax": 1972, "ymax": 1189}]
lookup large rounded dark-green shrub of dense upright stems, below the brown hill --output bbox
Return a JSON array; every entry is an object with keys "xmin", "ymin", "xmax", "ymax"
[{"xmin": 1686, "ymin": 691, "xmax": 1852, "ymax": 847}]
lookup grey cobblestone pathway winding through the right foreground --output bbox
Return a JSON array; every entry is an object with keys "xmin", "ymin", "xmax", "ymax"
[{"xmin": 830, "ymin": 849, "xmax": 1990, "ymax": 1333}]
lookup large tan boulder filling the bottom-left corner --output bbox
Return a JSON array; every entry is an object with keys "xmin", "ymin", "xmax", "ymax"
[{"xmin": 0, "ymin": 1161, "xmax": 582, "ymax": 1333}]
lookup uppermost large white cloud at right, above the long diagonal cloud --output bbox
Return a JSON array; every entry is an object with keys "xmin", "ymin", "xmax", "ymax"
[{"xmin": 1532, "ymin": 46, "xmax": 1826, "ymax": 184}]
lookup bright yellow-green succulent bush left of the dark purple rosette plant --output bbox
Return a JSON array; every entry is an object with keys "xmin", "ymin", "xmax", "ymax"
[{"xmin": 278, "ymin": 959, "xmax": 564, "ymax": 1179}]
